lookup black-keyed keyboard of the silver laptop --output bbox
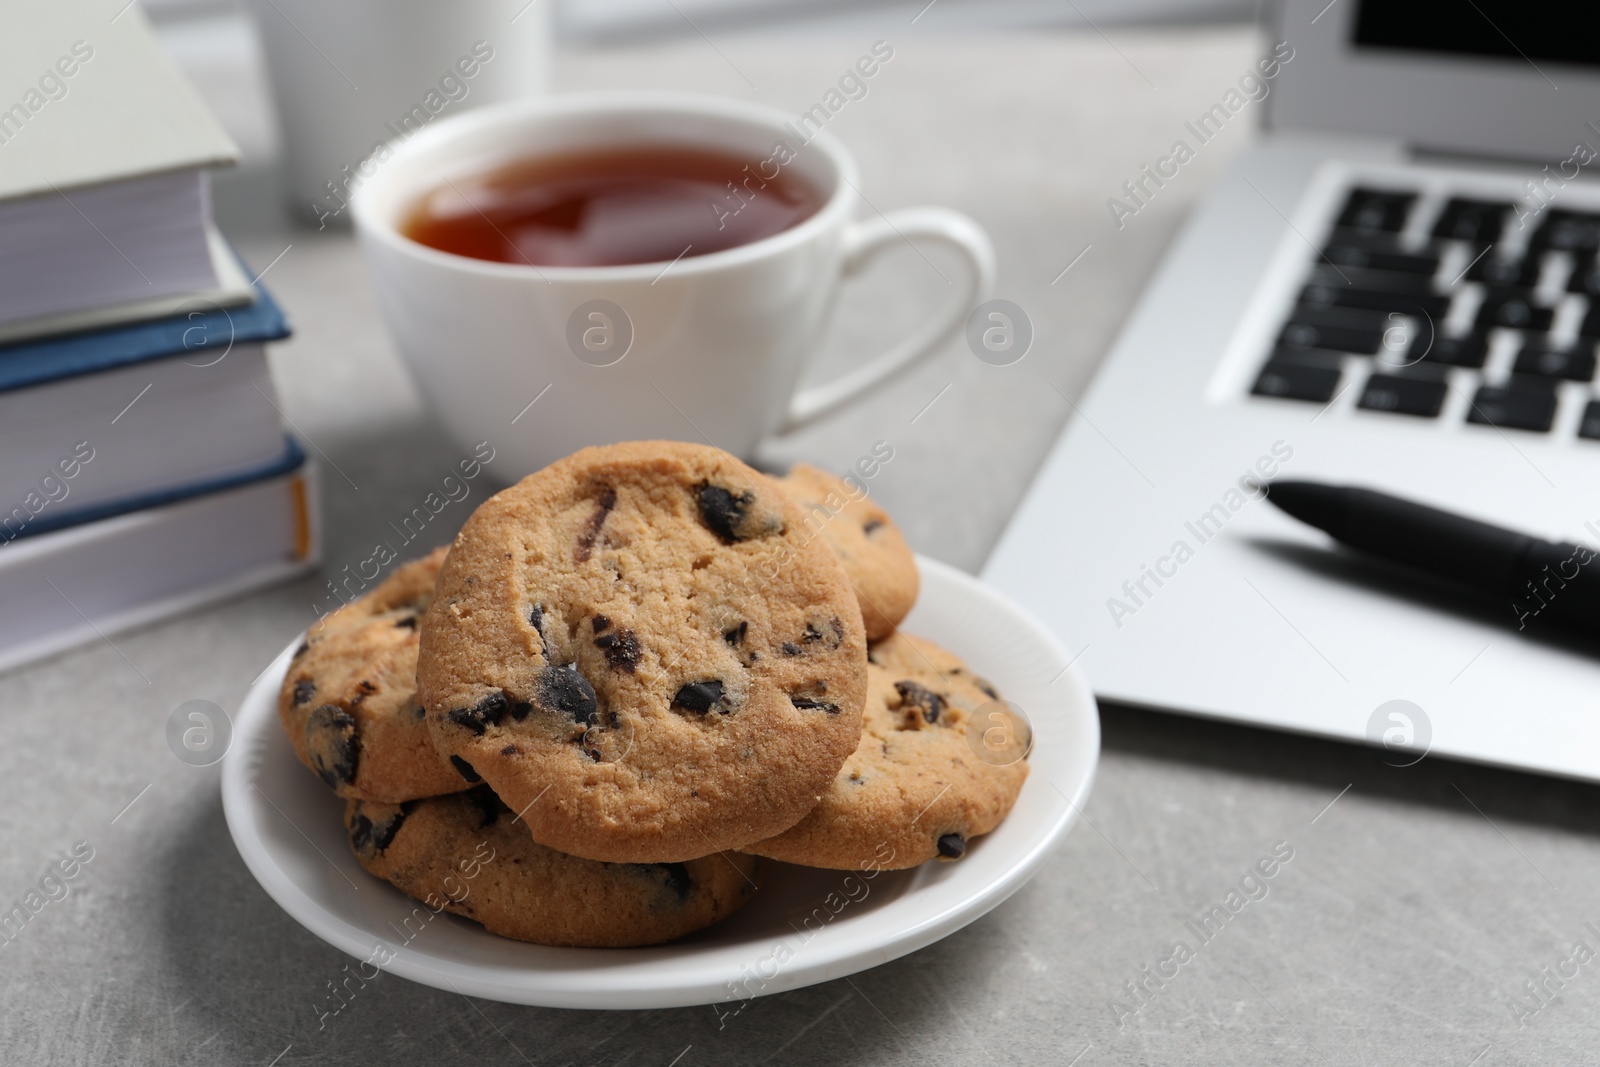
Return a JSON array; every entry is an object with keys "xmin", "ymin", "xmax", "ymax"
[{"xmin": 1251, "ymin": 186, "xmax": 1600, "ymax": 442}]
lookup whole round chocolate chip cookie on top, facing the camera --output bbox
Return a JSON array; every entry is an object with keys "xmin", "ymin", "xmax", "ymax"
[{"xmin": 418, "ymin": 442, "xmax": 867, "ymax": 862}]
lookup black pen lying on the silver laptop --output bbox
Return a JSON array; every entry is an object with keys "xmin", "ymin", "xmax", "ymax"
[{"xmin": 1267, "ymin": 482, "xmax": 1600, "ymax": 630}]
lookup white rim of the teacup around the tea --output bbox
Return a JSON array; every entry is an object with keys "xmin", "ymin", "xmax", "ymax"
[{"xmin": 350, "ymin": 90, "xmax": 859, "ymax": 283}]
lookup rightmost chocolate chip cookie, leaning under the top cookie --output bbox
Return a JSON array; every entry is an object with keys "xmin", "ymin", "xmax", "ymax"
[{"xmin": 744, "ymin": 632, "xmax": 1027, "ymax": 870}]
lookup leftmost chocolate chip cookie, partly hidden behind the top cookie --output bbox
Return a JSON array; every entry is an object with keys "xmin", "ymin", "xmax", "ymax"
[{"xmin": 278, "ymin": 549, "xmax": 469, "ymax": 801}]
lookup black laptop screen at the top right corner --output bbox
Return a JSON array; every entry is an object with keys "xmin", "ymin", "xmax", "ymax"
[{"xmin": 1352, "ymin": 0, "xmax": 1600, "ymax": 66}]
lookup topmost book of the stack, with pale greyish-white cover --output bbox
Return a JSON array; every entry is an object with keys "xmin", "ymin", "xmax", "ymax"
[{"xmin": 0, "ymin": 0, "xmax": 246, "ymax": 338}]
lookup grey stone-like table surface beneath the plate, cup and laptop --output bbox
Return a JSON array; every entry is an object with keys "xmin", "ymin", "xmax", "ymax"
[{"xmin": 0, "ymin": 18, "xmax": 1600, "ymax": 1067}]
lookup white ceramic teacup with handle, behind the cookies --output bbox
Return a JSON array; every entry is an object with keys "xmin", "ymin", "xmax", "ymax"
[{"xmin": 352, "ymin": 93, "xmax": 994, "ymax": 472}]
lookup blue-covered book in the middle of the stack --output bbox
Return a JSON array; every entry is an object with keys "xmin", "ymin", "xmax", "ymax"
[{"xmin": 0, "ymin": 271, "xmax": 298, "ymax": 545}]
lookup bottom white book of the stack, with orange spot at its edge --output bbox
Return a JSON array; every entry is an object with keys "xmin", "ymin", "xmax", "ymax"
[{"xmin": 0, "ymin": 461, "xmax": 322, "ymax": 670}]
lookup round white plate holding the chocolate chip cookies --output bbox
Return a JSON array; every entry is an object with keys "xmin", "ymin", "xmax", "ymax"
[{"xmin": 222, "ymin": 560, "xmax": 1099, "ymax": 1011}]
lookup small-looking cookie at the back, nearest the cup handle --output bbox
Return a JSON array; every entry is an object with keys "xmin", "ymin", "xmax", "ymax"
[{"xmin": 779, "ymin": 464, "xmax": 922, "ymax": 641}]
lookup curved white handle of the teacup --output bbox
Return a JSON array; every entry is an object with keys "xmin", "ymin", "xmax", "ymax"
[{"xmin": 778, "ymin": 208, "xmax": 995, "ymax": 434}]
